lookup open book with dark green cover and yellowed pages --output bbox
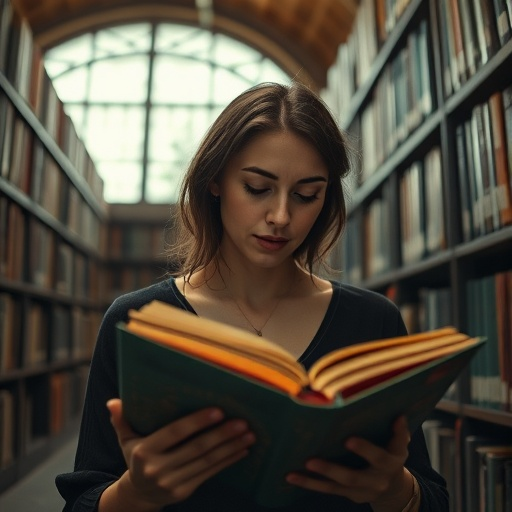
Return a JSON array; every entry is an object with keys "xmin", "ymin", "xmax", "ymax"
[{"xmin": 117, "ymin": 301, "xmax": 483, "ymax": 506}]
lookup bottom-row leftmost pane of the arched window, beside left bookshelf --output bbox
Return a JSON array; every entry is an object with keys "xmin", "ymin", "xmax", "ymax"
[{"xmin": 96, "ymin": 161, "xmax": 142, "ymax": 203}]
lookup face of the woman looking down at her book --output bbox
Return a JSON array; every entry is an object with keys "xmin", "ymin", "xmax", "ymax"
[{"xmin": 211, "ymin": 131, "xmax": 328, "ymax": 268}]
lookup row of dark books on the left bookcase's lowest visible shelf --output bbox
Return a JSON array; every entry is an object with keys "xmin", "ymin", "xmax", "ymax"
[{"xmin": 0, "ymin": 365, "xmax": 88, "ymax": 469}]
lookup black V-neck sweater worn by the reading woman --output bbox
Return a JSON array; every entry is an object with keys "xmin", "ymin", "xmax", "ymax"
[{"xmin": 56, "ymin": 279, "xmax": 448, "ymax": 512}]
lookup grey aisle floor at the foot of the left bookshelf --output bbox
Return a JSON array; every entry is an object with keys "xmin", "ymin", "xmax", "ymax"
[{"xmin": 0, "ymin": 438, "xmax": 77, "ymax": 512}]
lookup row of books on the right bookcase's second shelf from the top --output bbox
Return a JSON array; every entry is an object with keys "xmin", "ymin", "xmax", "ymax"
[{"xmin": 344, "ymin": 81, "xmax": 512, "ymax": 282}]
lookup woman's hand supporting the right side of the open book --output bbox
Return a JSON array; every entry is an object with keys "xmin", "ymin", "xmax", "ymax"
[{"xmin": 287, "ymin": 417, "xmax": 414, "ymax": 512}]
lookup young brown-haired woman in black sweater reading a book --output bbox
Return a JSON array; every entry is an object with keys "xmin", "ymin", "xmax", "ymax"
[{"xmin": 57, "ymin": 84, "xmax": 448, "ymax": 512}]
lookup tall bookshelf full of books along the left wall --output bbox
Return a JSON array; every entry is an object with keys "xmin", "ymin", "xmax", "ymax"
[{"xmin": 0, "ymin": 0, "xmax": 108, "ymax": 492}]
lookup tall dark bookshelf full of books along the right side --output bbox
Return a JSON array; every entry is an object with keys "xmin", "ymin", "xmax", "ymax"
[{"xmin": 323, "ymin": 0, "xmax": 512, "ymax": 512}]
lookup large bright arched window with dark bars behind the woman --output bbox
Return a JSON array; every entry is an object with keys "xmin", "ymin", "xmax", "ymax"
[{"xmin": 45, "ymin": 23, "xmax": 289, "ymax": 204}]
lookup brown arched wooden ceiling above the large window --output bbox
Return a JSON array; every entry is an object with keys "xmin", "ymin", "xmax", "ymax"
[{"xmin": 13, "ymin": 0, "xmax": 358, "ymax": 88}]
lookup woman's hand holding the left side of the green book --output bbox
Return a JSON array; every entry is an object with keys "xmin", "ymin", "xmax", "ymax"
[{"xmin": 99, "ymin": 399, "xmax": 255, "ymax": 512}]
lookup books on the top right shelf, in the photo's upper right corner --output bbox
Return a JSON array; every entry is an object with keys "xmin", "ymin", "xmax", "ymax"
[{"xmin": 437, "ymin": 0, "xmax": 512, "ymax": 97}]
